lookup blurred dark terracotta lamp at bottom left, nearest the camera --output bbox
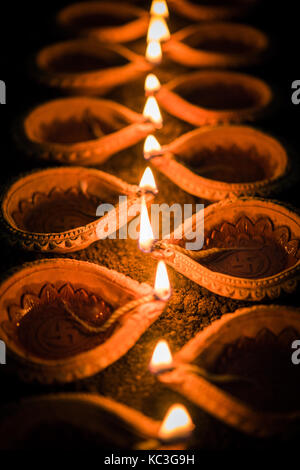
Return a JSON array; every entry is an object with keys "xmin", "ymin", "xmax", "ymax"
[{"xmin": 0, "ymin": 393, "xmax": 159, "ymax": 450}]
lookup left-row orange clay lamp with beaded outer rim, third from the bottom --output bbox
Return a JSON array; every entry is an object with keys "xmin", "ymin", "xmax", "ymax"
[{"xmin": 1, "ymin": 167, "xmax": 156, "ymax": 253}]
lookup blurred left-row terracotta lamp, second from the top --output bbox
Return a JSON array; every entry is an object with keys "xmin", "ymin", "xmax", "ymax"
[{"xmin": 35, "ymin": 38, "xmax": 153, "ymax": 95}]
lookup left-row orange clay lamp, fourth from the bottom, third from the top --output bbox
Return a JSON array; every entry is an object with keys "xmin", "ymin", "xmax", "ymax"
[{"xmin": 16, "ymin": 97, "xmax": 155, "ymax": 166}]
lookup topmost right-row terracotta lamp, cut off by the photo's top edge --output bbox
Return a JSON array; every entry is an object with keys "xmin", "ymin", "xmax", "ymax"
[{"xmin": 168, "ymin": 0, "xmax": 257, "ymax": 22}]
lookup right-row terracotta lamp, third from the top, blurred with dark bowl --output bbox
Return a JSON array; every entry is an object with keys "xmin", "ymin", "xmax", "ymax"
[{"xmin": 156, "ymin": 70, "xmax": 273, "ymax": 127}]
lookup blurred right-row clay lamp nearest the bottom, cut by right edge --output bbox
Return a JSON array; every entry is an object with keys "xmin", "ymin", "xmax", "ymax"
[{"xmin": 152, "ymin": 305, "xmax": 300, "ymax": 437}]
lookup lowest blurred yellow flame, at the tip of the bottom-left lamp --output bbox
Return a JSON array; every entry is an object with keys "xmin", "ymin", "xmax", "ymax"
[{"xmin": 158, "ymin": 404, "xmax": 195, "ymax": 441}]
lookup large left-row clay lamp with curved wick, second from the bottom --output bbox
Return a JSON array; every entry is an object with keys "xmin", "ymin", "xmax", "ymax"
[{"xmin": 0, "ymin": 258, "xmax": 166, "ymax": 383}]
